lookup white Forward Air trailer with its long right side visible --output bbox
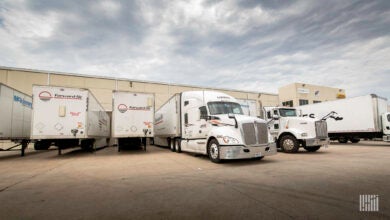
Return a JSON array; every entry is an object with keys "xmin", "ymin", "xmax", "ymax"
[{"xmin": 31, "ymin": 85, "xmax": 110, "ymax": 154}]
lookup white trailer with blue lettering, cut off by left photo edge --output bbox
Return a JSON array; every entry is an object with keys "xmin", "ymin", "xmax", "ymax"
[{"xmin": 0, "ymin": 83, "xmax": 32, "ymax": 156}]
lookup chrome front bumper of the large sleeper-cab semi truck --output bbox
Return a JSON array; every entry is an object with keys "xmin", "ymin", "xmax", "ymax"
[{"xmin": 219, "ymin": 143, "xmax": 277, "ymax": 160}]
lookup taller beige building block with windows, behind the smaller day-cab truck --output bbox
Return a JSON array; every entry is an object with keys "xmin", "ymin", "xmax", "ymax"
[{"xmin": 279, "ymin": 83, "xmax": 346, "ymax": 107}]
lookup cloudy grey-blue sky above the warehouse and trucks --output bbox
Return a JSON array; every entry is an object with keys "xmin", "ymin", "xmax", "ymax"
[{"xmin": 0, "ymin": 0, "xmax": 390, "ymax": 99}]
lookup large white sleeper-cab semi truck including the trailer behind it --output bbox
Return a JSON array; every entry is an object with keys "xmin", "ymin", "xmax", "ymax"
[{"xmin": 154, "ymin": 91, "xmax": 276, "ymax": 163}]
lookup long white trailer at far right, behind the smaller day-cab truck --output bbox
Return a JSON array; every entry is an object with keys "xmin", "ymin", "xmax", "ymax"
[{"xmin": 299, "ymin": 94, "xmax": 390, "ymax": 143}]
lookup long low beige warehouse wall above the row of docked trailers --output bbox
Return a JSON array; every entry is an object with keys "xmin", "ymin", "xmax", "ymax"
[{"xmin": 0, "ymin": 67, "xmax": 279, "ymax": 115}]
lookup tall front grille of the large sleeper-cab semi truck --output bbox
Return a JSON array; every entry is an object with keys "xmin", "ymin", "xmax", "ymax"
[{"xmin": 242, "ymin": 123, "xmax": 268, "ymax": 145}]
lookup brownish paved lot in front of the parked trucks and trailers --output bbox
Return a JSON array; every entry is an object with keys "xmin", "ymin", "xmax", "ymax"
[{"xmin": 0, "ymin": 142, "xmax": 390, "ymax": 219}]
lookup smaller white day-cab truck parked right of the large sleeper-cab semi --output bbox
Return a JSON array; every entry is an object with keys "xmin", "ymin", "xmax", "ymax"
[{"xmin": 264, "ymin": 107, "xmax": 329, "ymax": 153}]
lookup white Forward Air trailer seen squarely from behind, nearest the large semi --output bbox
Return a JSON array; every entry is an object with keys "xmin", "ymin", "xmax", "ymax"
[{"xmin": 111, "ymin": 91, "xmax": 154, "ymax": 151}]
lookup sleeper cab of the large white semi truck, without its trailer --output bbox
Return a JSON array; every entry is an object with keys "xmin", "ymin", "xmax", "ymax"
[{"xmin": 180, "ymin": 91, "xmax": 276, "ymax": 162}]
